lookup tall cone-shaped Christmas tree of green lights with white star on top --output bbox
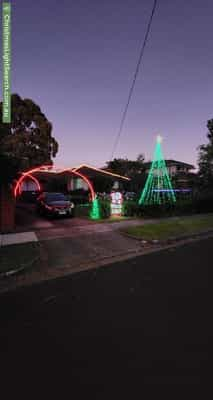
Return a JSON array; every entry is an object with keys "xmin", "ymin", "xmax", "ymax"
[{"xmin": 139, "ymin": 136, "xmax": 176, "ymax": 205}]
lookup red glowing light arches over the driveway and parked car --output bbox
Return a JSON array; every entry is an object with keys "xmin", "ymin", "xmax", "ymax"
[{"xmin": 14, "ymin": 165, "xmax": 96, "ymax": 201}]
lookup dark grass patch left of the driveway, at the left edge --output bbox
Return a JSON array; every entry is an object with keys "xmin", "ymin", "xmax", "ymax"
[{"xmin": 0, "ymin": 243, "xmax": 40, "ymax": 274}]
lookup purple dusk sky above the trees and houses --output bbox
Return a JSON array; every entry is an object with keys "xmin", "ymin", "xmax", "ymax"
[{"xmin": 2, "ymin": 0, "xmax": 213, "ymax": 167}]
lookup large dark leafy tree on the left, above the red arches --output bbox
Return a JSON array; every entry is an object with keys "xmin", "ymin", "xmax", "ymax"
[{"xmin": 0, "ymin": 94, "xmax": 58, "ymax": 170}]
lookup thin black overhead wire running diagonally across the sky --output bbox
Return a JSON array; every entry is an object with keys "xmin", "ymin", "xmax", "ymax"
[{"xmin": 110, "ymin": 0, "xmax": 157, "ymax": 161}]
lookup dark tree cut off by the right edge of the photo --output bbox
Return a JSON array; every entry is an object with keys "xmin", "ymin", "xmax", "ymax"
[{"xmin": 198, "ymin": 119, "xmax": 213, "ymax": 192}]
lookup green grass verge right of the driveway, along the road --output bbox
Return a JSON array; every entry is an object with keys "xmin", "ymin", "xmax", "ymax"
[{"xmin": 122, "ymin": 214, "xmax": 213, "ymax": 240}]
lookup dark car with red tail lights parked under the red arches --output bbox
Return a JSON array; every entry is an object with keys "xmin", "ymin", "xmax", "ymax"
[{"xmin": 37, "ymin": 192, "xmax": 74, "ymax": 217}]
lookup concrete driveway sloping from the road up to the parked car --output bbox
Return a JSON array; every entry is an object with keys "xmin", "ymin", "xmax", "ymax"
[{"xmin": 9, "ymin": 206, "xmax": 211, "ymax": 288}]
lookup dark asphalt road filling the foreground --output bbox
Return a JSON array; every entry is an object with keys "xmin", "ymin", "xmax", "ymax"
[{"xmin": 0, "ymin": 238, "xmax": 210, "ymax": 399}]
